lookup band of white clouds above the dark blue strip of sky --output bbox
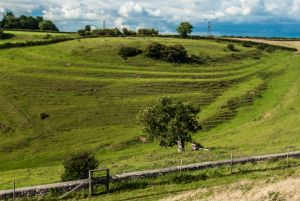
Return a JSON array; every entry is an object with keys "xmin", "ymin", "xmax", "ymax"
[{"xmin": 0, "ymin": 0, "xmax": 300, "ymax": 30}]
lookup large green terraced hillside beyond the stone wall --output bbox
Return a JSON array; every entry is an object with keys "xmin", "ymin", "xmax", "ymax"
[{"xmin": 0, "ymin": 35, "xmax": 300, "ymax": 192}]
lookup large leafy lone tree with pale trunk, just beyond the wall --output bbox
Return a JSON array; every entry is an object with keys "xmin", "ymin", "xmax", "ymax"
[{"xmin": 138, "ymin": 98, "xmax": 201, "ymax": 153}]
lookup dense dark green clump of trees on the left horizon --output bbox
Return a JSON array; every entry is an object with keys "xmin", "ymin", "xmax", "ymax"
[{"xmin": 0, "ymin": 12, "xmax": 59, "ymax": 31}]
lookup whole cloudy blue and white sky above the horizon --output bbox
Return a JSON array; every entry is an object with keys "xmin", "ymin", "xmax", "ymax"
[{"xmin": 0, "ymin": 0, "xmax": 300, "ymax": 37}]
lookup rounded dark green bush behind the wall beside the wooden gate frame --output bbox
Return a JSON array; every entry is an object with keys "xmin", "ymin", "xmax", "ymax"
[{"xmin": 62, "ymin": 151, "xmax": 99, "ymax": 181}]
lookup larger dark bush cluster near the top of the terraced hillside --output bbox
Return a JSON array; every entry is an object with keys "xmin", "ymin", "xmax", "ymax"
[{"xmin": 146, "ymin": 42, "xmax": 189, "ymax": 63}]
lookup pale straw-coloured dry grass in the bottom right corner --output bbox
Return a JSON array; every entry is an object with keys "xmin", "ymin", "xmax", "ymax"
[{"xmin": 163, "ymin": 177, "xmax": 300, "ymax": 201}]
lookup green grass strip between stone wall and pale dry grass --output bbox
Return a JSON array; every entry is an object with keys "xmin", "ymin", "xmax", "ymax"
[{"xmin": 19, "ymin": 159, "xmax": 300, "ymax": 201}]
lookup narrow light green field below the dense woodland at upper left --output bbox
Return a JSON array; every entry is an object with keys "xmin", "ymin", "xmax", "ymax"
[{"xmin": 0, "ymin": 31, "xmax": 76, "ymax": 44}]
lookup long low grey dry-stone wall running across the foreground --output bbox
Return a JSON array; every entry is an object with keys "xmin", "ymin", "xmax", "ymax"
[{"xmin": 0, "ymin": 151, "xmax": 300, "ymax": 200}]
